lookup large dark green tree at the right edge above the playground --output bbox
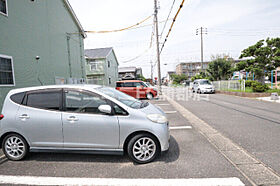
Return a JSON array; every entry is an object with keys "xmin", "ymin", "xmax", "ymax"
[{"xmin": 236, "ymin": 38, "xmax": 280, "ymax": 84}]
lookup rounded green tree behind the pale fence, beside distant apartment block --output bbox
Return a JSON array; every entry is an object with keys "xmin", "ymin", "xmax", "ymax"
[{"xmin": 206, "ymin": 55, "xmax": 233, "ymax": 81}]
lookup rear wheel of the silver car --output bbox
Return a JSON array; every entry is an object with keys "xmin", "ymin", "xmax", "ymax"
[{"xmin": 2, "ymin": 134, "xmax": 29, "ymax": 161}]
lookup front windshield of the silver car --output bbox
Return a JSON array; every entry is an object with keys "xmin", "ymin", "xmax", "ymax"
[{"xmin": 98, "ymin": 87, "xmax": 148, "ymax": 109}]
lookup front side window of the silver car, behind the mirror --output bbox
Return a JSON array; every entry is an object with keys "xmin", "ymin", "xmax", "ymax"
[{"xmin": 64, "ymin": 90, "xmax": 108, "ymax": 114}]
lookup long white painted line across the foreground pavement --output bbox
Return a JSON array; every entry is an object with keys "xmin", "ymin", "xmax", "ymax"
[{"xmin": 0, "ymin": 175, "xmax": 244, "ymax": 186}]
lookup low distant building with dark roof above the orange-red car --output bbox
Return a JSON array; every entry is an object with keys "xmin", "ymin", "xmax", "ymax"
[{"xmin": 119, "ymin": 67, "xmax": 143, "ymax": 80}]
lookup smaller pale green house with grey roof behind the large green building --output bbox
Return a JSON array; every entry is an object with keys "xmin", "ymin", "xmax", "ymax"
[{"xmin": 85, "ymin": 47, "xmax": 119, "ymax": 87}]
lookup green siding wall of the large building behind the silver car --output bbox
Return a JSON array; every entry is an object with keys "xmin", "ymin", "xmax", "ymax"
[{"xmin": 0, "ymin": 0, "xmax": 85, "ymax": 110}]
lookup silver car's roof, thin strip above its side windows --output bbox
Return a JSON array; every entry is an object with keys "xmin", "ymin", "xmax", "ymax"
[{"xmin": 7, "ymin": 84, "xmax": 102, "ymax": 94}]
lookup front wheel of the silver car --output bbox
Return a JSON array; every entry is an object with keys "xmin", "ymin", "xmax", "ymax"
[{"xmin": 127, "ymin": 133, "xmax": 160, "ymax": 164}]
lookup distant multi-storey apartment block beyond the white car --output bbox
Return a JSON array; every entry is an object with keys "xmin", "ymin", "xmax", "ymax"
[{"xmin": 176, "ymin": 62, "xmax": 210, "ymax": 78}]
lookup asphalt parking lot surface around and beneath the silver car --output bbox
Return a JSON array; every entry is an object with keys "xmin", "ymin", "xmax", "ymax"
[{"xmin": 0, "ymin": 100, "xmax": 250, "ymax": 185}]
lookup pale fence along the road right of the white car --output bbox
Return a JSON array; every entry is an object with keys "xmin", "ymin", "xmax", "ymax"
[{"xmin": 212, "ymin": 80, "xmax": 245, "ymax": 91}]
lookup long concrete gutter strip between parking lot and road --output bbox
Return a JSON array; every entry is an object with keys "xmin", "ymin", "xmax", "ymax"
[{"xmin": 164, "ymin": 96, "xmax": 280, "ymax": 185}]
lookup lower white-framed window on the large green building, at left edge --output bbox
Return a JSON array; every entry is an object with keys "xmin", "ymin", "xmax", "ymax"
[{"xmin": 0, "ymin": 55, "xmax": 15, "ymax": 86}]
